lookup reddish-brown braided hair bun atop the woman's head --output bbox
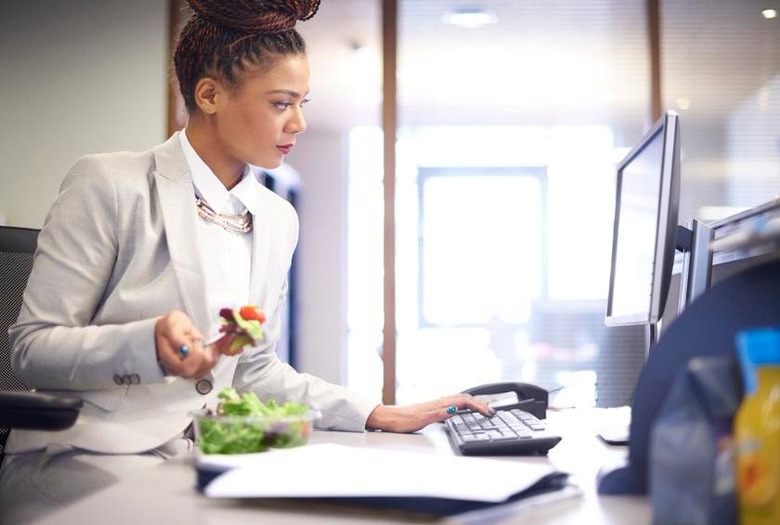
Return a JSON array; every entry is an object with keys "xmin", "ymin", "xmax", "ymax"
[{"xmin": 187, "ymin": 0, "xmax": 320, "ymax": 34}]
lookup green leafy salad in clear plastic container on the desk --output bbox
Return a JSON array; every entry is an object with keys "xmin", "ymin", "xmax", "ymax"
[{"xmin": 195, "ymin": 388, "xmax": 312, "ymax": 454}]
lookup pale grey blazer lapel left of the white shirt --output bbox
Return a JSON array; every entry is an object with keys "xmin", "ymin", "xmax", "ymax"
[{"xmin": 149, "ymin": 132, "xmax": 211, "ymax": 333}]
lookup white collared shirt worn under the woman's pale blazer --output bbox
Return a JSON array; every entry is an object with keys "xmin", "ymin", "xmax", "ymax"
[{"xmin": 179, "ymin": 130, "xmax": 260, "ymax": 339}]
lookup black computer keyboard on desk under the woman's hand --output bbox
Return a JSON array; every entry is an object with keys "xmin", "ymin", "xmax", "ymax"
[{"xmin": 445, "ymin": 408, "xmax": 561, "ymax": 456}]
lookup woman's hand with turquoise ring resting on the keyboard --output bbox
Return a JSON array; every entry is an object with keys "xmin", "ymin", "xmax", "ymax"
[{"xmin": 366, "ymin": 394, "xmax": 495, "ymax": 432}]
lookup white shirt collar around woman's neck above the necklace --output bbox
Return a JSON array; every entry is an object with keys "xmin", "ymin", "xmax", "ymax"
[{"xmin": 179, "ymin": 130, "xmax": 261, "ymax": 215}]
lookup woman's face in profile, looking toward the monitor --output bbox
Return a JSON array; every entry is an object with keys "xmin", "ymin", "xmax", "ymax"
[{"xmin": 212, "ymin": 55, "xmax": 309, "ymax": 169}]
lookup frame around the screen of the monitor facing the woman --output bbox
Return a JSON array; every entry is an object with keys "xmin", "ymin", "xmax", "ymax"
[{"xmin": 604, "ymin": 110, "xmax": 680, "ymax": 326}]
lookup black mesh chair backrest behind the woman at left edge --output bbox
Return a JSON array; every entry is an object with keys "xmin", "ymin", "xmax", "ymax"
[{"xmin": 0, "ymin": 226, "xmax": 39, "ymax": 463}]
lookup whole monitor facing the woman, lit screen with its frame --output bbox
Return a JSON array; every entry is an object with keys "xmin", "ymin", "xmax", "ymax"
[{"xmin": 605, "ymin": 111, "xmax": 680, "ymax": 325}]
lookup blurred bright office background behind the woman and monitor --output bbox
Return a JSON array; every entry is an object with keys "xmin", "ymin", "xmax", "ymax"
[{"xmin": 0, "ymin": 0, "xmax": 780, "ymax": 406}]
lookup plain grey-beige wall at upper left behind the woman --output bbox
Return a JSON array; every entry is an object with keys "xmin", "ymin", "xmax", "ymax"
[{"xmin": 0, "ymin": 0, "xmax": 168, "ymax": 227}]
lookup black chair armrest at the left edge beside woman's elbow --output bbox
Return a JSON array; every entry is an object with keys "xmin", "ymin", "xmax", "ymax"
[{"xmin": 0, "ymin": 392, "xmax": 83, "ymax": 430}]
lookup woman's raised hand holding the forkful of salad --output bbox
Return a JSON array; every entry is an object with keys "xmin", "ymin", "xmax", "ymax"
[{"xmin": 154, "ymin": 310, "xmax": 219, "ymax": 379}]
